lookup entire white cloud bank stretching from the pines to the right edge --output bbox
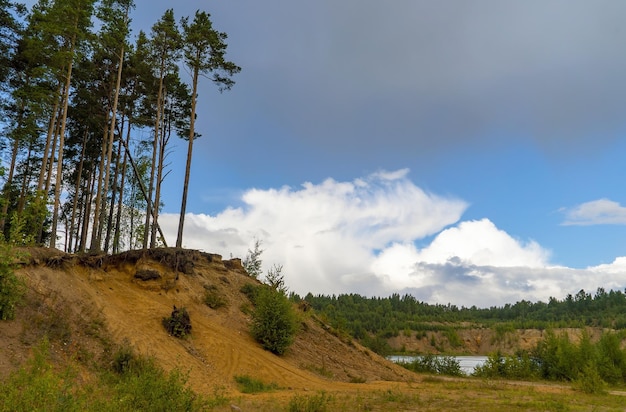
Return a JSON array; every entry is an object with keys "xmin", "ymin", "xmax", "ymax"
[{"xmin": 161, "ymin": 170, "xmax": 626, "ymax": 307}]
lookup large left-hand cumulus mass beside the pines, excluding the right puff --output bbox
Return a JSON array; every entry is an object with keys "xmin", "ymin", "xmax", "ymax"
[{"xmin": 161, "ymin": 170, "xmax": 467, "ymax": 294}]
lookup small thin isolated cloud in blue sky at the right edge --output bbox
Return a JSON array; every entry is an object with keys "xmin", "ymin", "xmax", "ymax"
[{"xmin": 562, "ymin": 199, "xmax": 626, "ymax": 226}]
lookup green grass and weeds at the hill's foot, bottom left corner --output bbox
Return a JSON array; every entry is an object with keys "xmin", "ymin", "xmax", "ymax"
[{"xmin": 0, "ymin": 339, "xmax": 226, "ymax": 412}]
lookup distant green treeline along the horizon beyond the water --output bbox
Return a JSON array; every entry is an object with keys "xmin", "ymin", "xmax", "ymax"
[{"xmin": 292, "ymin": 288, "xmax": 626, "ymax": 339}]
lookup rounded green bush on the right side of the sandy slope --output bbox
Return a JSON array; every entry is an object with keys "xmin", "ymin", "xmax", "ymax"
[{"xmin": 251, "ymin": 286, "xmax": 298, "ymax": 355}]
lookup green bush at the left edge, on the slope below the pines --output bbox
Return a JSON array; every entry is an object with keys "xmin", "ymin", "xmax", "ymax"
[{"xmin": 0, "ymin": 241, "xmax": 25, "ymax": 320}]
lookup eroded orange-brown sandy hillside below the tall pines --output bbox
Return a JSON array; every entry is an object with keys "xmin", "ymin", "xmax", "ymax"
[{"xmin": 0, "ymin": 248, "xmax": 416, "ymax": 393}]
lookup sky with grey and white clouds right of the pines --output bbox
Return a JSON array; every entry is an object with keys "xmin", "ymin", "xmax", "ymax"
[{"xmin": 20, "ymin": 0, "xmax": 626, "ymax": 307}]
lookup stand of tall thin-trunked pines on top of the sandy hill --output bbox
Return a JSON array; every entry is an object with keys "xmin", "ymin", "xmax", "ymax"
[{"xmin": 0, "ymin": 0, "xmax": 241, "ymax": 253}]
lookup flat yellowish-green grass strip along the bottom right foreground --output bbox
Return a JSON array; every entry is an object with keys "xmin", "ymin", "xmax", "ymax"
[{"xmin": 227, "ymin": 377, "xmax": 626, "ymax": 412}]
